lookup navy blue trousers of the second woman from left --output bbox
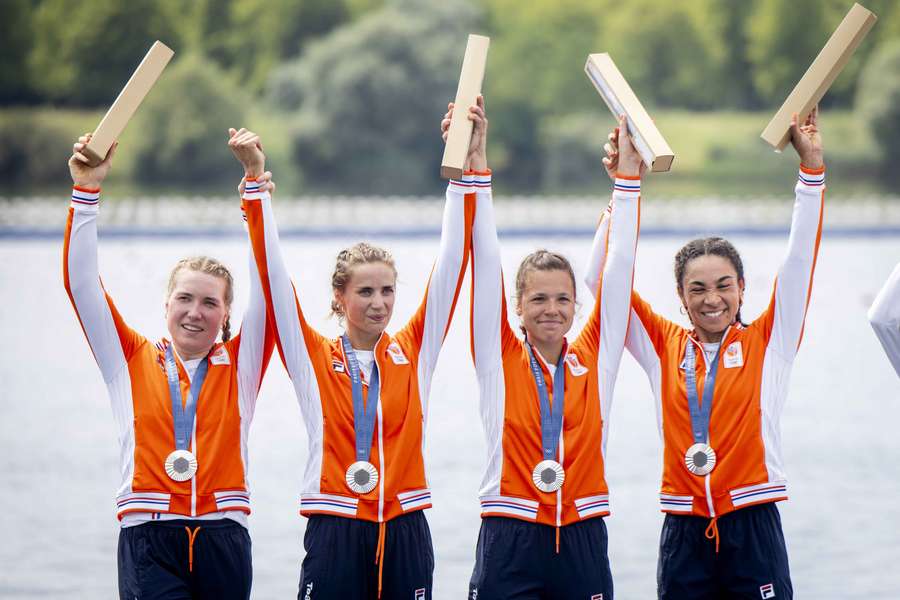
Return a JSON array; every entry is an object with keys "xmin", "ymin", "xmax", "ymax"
[{"xmin": 297, "ymin": 510, "xmax": 434, "ymax": 600}]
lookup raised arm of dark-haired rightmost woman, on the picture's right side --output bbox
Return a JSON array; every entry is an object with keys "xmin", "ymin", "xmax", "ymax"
[{"xmin": 754, "ymin": 109, "xmax": 825, "ymax": 361}]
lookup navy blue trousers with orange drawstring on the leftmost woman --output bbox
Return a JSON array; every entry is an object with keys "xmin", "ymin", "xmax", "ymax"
[{"xmin": 118, "ymin": 519, "xmax": 253, "ymax": 600}]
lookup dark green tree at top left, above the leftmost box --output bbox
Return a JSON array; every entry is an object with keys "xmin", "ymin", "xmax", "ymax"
[{"xmin": 28, "ymin": 0, "xmax": 182, "ymax": 106}]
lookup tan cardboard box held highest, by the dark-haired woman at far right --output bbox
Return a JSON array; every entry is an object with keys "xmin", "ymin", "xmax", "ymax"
[{"xmin": 760, "ymin": 4, "xmax": 878, "ymax": 152}]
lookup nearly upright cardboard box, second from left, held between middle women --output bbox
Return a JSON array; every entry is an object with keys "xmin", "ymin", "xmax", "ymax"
[{"xmin": 441, "ymin": 34, "xmax": 491, "ymax": 179}]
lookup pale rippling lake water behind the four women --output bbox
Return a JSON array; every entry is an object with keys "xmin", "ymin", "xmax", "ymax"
[{"xmin": 0, "ymin": 234, "xmax": 900, "ymax": 600}]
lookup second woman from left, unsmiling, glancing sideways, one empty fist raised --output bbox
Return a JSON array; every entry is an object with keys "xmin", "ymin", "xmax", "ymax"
[{"xmin": 229, "ymin": 111, "xmax": 474, "ymax": 600}]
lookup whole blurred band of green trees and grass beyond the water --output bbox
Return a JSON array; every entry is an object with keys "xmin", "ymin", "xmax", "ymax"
[{"xmin": 0, "ymin": 0, "xmax": 900, "ymax": 194}]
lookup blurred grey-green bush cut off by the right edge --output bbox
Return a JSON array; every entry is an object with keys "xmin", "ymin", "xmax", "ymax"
[{"xmin": 856, "ymin": 40, "xmax": 900, "ymax": 183}]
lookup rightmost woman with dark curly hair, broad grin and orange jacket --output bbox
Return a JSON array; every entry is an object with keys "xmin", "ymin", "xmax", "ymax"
[{"xmin": 587, "ymin": 109, "xmax": 825, "ymax": 600}]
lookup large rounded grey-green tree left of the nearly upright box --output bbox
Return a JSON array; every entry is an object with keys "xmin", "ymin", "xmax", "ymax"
[{"xmin": 271, "ymin": 0, "xmax": 477, "ymax": 194}]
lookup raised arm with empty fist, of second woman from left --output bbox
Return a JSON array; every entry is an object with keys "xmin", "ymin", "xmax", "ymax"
[{"xmin": 228, "ymin": 129, "xmax": 324, "ymax": 391}]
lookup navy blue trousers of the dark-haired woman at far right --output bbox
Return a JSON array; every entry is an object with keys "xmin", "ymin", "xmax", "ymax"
[{"xmin": 656, "ymin": 502, "xmax": 794, "ymax": 600}]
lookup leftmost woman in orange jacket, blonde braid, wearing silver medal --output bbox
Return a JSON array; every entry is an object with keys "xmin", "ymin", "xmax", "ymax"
[{"xmin": 63, "ymin": 134, "xmax": 274, "ymax": 600}]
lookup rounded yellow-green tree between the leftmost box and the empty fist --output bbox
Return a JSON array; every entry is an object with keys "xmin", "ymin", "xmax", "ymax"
[{"xmin": 130, "ymin": 54, "xmax": 247, "ymax": 185}]
